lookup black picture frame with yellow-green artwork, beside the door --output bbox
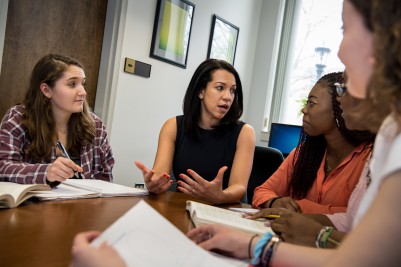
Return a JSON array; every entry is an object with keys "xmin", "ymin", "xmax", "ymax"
[{"xmin": 150, "ymin": 0, "xmax": 195, "ymax": 69}]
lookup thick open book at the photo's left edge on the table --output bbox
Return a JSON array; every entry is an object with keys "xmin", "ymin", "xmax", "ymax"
[{"xmin": 0, "ymin": 182, "xmax": 50, "ymax": 208}]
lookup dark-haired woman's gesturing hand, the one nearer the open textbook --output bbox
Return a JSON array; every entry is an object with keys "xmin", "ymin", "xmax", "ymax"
[{"xmin": 177, "ymin": 166, "xmax": 227, "ymax": 204}]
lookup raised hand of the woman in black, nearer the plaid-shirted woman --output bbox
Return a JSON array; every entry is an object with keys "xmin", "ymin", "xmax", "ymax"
[{"xmin": 135, "ymin": 161, "xmax": 173, "ymax": 194}]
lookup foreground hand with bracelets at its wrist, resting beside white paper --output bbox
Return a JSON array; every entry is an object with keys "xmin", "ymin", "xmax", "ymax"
[{"xmin": 187, "ymin": 224, "xmax": 252, "ymax": 259}]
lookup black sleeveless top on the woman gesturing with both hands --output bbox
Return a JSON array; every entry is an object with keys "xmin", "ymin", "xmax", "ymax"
[{"xmin": 173, "ymin": 115, "xmax": 245, "ymax": 189}]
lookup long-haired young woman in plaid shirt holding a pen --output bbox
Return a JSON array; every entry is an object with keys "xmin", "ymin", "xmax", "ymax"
[{"xmin": 0, "ymin": 54, "xmax": 114, "ymax": 185}]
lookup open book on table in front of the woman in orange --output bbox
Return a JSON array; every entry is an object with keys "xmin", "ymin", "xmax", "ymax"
[{"xmin": 186, "ymin": 201, "xmax": 273, "ymax": 234}]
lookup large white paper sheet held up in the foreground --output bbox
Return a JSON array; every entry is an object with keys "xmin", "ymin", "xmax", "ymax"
[{"xmin": 92, "ymin": 200, "xmax": 248, "ymax": 267}]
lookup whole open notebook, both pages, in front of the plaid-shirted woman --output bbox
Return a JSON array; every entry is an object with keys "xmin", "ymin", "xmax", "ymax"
[{"xmin": 35, "ymin": 179, "xmax": 148, "ymax": 200}]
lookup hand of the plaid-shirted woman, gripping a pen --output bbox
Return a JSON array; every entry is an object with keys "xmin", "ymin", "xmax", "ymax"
[{"xmin": 46, "ymin": 157, "xmax": 83, "ymax": 182}]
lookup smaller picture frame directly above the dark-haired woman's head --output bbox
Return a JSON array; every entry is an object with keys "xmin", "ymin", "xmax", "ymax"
[{"xmin": 207, "ymin": 14, "xmax": 239, "ymax": 65}]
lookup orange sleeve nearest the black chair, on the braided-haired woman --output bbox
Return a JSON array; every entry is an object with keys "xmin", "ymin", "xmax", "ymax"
[{"xmin": 252, "ymin": 149, "xmax": 295, "ymax": 208}]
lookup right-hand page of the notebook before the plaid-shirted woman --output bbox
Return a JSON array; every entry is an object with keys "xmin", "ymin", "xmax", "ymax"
[{"xmin": 63, "ymin": 179, "xmax": 148, "ymax": 197}]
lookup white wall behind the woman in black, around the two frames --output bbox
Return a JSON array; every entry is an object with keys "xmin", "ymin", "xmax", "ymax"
[{"xmin": 108, "ymin": 0, "xmax": 284, "ymax": 185}]
